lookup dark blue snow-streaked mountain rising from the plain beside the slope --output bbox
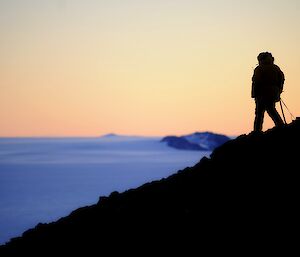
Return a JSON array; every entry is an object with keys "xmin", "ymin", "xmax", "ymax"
[{"xmin": 161, "ymin": 132, "xmax": 230, "ymax": 151}]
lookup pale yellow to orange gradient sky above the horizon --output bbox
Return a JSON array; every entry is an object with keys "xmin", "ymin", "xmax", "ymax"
[{"xmin": 0, "ymin": 0, "xmax": 300, "ymax": 137}]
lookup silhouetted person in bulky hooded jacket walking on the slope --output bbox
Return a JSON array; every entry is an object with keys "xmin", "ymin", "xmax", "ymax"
[{"xmin": 251, "ymin": 52, "xmax": 285, "ymax": 132}]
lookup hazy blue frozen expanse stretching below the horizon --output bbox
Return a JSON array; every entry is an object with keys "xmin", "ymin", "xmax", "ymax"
[{"xmin": 0, "ymin": 135, "xmax": 211, "ymax": 244}]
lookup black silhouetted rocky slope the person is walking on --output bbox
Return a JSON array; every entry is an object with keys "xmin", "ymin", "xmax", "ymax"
[{"xmin": 0, "ymin": 121, "xmax": 300, "ymax": 253}]
